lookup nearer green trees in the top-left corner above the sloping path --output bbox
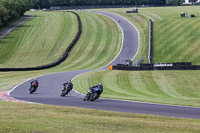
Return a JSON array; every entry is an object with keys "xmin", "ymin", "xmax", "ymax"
[{"xmin": 0, "ymin": 0, "xmax": 33, "ymax": 26}]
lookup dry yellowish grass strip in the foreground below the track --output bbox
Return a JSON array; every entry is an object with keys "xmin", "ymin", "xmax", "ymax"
[{"xmin": 0, "ymin": 102, "xmax": 200, "ymax": 133}]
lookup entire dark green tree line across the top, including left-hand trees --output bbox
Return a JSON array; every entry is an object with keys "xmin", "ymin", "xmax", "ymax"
[{"xmin": 0, "ymin": 0, "xmax": 197, "ymax": 26}]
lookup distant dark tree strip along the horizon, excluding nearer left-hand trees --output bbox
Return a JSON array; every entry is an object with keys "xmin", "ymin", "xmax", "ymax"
[{"xmin": 32, "ymin": 0, "xmax": 197, "ymax": 9}]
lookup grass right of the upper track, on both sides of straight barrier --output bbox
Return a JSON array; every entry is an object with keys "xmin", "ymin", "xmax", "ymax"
[{"xmin": 97, "ymin": 6, "xmax": 200, "ymax": 65}]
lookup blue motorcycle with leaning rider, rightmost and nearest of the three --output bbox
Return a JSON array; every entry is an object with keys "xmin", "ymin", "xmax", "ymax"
[{"xmin": 83, "ymin": 88, "xmax": 102, "ymax": 101}]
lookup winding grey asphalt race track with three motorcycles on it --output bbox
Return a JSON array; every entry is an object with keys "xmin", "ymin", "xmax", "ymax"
[{"xmin": 9, "ymin": 12, "xmax": 200, "ymax": 119}]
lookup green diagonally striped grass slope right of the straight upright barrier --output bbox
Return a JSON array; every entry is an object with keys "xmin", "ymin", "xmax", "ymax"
[{"xmin": 152, "ymin": 6, "xmax": 200, "ymax": 65}]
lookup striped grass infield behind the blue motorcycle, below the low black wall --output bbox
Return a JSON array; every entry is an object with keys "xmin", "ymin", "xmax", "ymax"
[{"xmin": 73, "ymin": 70, "xmax": 200, "ymax": 107}]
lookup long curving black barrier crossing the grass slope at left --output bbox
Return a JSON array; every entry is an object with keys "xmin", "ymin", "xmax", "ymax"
[{"xmin": 0, "ymin": 11, "xmax": 82, "ymax": 71}]
